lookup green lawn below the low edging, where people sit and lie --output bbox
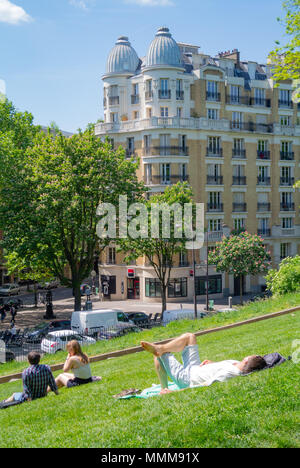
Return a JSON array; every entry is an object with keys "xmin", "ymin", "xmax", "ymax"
[{"xmin": 0, "ymin": 302, "xmax": 300, "ymax": 448}]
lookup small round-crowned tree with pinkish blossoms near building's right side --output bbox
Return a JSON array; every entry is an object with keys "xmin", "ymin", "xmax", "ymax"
[{"xmin": 208, "ymin": 232, "xmax": 271, "ymax": 304}]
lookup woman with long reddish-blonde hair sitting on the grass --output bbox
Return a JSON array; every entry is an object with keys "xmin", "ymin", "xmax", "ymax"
[{"xmin": 55, "ymin": 340, "xmax": 93, "ymax": 388}]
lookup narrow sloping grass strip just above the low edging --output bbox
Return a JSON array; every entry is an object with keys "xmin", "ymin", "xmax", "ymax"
[{"xmin": 0, "ymin": 293, "xmax": 300, "ymax": 375}]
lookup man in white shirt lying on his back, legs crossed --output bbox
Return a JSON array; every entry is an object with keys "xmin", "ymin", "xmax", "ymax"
[{"xmin": 141, "ymin": 333, "xmax": 266, "ymax": 394}]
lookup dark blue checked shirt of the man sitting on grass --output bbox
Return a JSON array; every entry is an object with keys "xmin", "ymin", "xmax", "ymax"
[{"xmin": 22, "ymin": 365, "xmax": 57, "ymax": 401}]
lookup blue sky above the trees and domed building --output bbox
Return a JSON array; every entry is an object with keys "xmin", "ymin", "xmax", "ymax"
[{"xmin": 0, "ymin": 0, "xmax": 284, "ymax": 131}]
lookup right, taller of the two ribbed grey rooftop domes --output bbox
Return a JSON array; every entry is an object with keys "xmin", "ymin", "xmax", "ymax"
[{"xmin": 145, "ymin": 27, "xmax": 182, "ymax": 67}]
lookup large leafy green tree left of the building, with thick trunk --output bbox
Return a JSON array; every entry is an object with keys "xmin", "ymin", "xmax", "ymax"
[{"xmin": 0, "ymin": 122, "xmax": 143, "ymax": 310}]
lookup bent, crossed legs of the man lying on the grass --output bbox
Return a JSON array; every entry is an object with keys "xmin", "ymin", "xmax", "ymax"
[{"xmin": 141, "ymin": 333, "xmax": 200, "ymax": 393}]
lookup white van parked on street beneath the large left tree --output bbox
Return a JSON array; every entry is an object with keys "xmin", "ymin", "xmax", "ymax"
[{"xmin": 71, "ymin": 309, "xmax": 130, "ymax": 335}]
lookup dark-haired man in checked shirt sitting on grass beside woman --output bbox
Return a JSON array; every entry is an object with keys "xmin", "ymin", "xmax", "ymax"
[{"xmin": 3, "ymin": 351, "xmax": 58, "ymax": 403}]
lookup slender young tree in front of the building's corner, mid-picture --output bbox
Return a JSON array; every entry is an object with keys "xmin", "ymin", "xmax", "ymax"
[{"xmin": 118, "ymin": 182, "xmax": 199, "ymax": 315}]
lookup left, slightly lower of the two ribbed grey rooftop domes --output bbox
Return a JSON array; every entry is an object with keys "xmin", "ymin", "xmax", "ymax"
[{"xmin": 106, "ymin": 36, "xmax": 139, "ymax": 73}]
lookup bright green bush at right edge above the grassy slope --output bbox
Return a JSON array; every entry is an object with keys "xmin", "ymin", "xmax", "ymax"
[{"xmin": 266, "ymin": 255, "xmax": 300, "ymax": 295}]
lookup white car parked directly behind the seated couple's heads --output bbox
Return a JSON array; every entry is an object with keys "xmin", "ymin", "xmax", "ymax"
[{"xmin": 41, "ymin": 330, "xmax": 96, "ymax": 354}]
